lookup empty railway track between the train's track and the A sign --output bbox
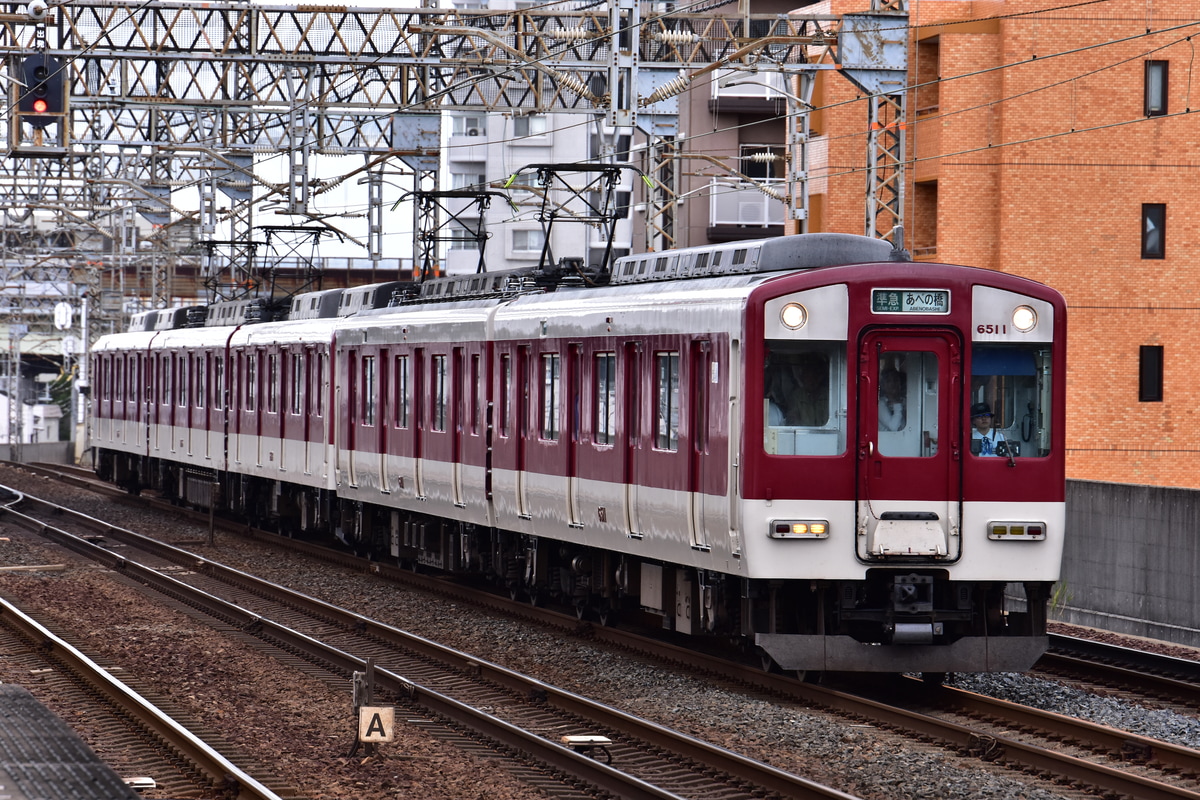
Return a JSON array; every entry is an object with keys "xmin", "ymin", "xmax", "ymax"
[{"xmin": 2, "ymin": 479, "xmax": 852, "ymax": 800}]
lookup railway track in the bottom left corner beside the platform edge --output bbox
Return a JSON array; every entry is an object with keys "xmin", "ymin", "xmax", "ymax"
[{"xmin": 0, "ymin": 582, "xmax": 295, "ymax": 800}]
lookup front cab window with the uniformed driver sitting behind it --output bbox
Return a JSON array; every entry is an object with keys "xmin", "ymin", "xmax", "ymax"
[{"xmin": 965, "ymin": 343, "xmax": 1054, "ymax": 457}]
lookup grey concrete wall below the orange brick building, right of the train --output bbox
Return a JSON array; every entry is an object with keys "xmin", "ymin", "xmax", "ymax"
[{"xmin": 1050, "ymin": 481, "xmax": 1200, "ymax": 646}]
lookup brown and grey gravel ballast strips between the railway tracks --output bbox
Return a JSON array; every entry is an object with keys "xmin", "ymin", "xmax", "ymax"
[{"xmin": 0, "ymin": 468, "xmax": 1200, "ymax": 800}]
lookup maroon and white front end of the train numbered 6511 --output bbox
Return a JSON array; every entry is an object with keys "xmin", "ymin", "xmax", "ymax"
[{"xmin": 742, "ymin": 250, "xmax": 1066, "ymax": 675}]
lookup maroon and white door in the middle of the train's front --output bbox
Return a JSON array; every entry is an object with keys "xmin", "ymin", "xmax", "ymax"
[{"xmin": 856, "ymin": 330, "xmax": 964, "ymax": 561}]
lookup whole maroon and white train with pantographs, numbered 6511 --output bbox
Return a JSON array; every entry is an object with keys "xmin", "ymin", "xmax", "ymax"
[{"xmin": 91, "ymin": 234, "xmax": 1067, "ymax": 673}]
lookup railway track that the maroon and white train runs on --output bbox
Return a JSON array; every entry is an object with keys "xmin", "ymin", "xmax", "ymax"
[{"xmin": 14, "ymin": 462, "xmax": 1200, "ymax": 799}]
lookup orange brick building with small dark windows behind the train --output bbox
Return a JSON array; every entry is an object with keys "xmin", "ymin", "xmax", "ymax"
[{"xmin": 797, "ymin": 0, "xmax": 1200, "ymax": 488}]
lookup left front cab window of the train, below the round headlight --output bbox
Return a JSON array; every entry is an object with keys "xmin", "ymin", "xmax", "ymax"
[{"xmin": 763, "ymin": 342, "xmax": 846, "ymax": 456}]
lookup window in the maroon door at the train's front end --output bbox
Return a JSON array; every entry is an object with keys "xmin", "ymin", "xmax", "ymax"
[{"xmin": 876, "ymin": 350, "xmax": 941, "ymax": 458}]
